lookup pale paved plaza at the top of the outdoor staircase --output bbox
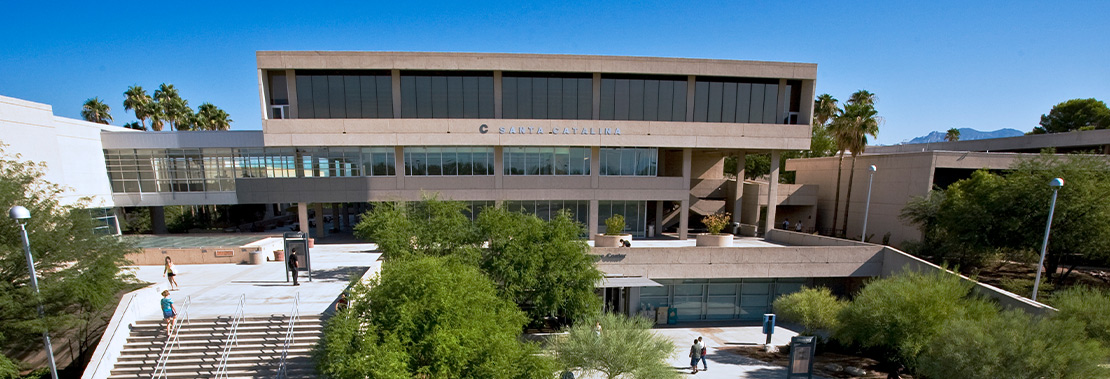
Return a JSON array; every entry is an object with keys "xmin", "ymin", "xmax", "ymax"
[{"xmin": 127, "ymin": 243, "xmax": 382, "ymax": 319}]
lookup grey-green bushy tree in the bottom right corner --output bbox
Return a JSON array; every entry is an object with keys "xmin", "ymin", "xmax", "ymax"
[{"xmin": 917, "ymin": 310, "xmax": 1107, "ymax": 379}]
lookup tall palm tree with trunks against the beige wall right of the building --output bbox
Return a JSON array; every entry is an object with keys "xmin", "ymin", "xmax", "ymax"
[{"xmin": 833, "ymin": 90, "xmax": 882, "ymax": 233}]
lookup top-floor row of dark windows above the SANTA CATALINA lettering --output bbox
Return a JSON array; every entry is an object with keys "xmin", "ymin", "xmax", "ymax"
[{"xmin": 269, "ymin": 70, "xmax": 800, "ymax": 123}]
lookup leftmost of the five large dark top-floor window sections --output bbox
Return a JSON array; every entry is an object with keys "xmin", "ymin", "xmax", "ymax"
[{"xmin": 296, "ymin": 70, "xmax": 393, "ymax": 119}]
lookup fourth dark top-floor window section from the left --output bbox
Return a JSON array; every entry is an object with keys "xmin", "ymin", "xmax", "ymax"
[{"xmin": 601, "ymin": 74, "xmax": 688, "ymax": 121}]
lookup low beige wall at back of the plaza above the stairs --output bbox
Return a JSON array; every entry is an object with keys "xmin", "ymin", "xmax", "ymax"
[{"xmin": 127, "ymin": 238, "xmax": 282, "ymax": 266}]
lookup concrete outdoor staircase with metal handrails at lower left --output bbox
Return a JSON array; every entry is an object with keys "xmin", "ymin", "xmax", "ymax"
[{"xmin": 109, "ymin": 315, "xmax": 323, "ymax": 378}]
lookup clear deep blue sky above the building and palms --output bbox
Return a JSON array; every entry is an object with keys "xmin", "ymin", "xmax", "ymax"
[{"xmin": 0, "ymin": 1, "xmax": 1110, "ymax": 143}]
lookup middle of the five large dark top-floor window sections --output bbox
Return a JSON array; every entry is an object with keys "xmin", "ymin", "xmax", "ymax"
[{"xmin": 501, "ymin": 72, "xmax": 594, "ymax": 120}]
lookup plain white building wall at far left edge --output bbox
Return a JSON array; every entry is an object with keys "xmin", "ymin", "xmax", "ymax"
[{"xmin": 0, "ymin": 96, "xmax": 130, "ymax": 207}]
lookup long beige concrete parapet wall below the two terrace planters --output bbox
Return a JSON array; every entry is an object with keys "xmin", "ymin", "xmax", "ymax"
[{"xmin": 591, "ymin": 246, "xmax": 882, "ymax": 279}]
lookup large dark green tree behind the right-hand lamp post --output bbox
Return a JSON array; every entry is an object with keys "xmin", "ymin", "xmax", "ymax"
[{"xmin": 901, "ymin": 153, "xmax": 1110, "ymax": 275}]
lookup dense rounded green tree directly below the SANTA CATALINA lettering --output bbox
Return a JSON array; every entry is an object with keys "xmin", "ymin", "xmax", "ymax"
[{"xmin": 477, "ymin": 208, "xmax": 602, "ymax": 322}]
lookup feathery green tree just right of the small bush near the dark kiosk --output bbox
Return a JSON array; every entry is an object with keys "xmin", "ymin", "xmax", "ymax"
[{"xmin": 835, "ymin": 266, "xmax": 998, "ymax": 369}]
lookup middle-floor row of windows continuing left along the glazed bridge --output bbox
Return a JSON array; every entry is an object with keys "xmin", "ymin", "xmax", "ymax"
[{"xmin": 104, "ymin": 147, "xmax": 658, "ymax": 192}]
